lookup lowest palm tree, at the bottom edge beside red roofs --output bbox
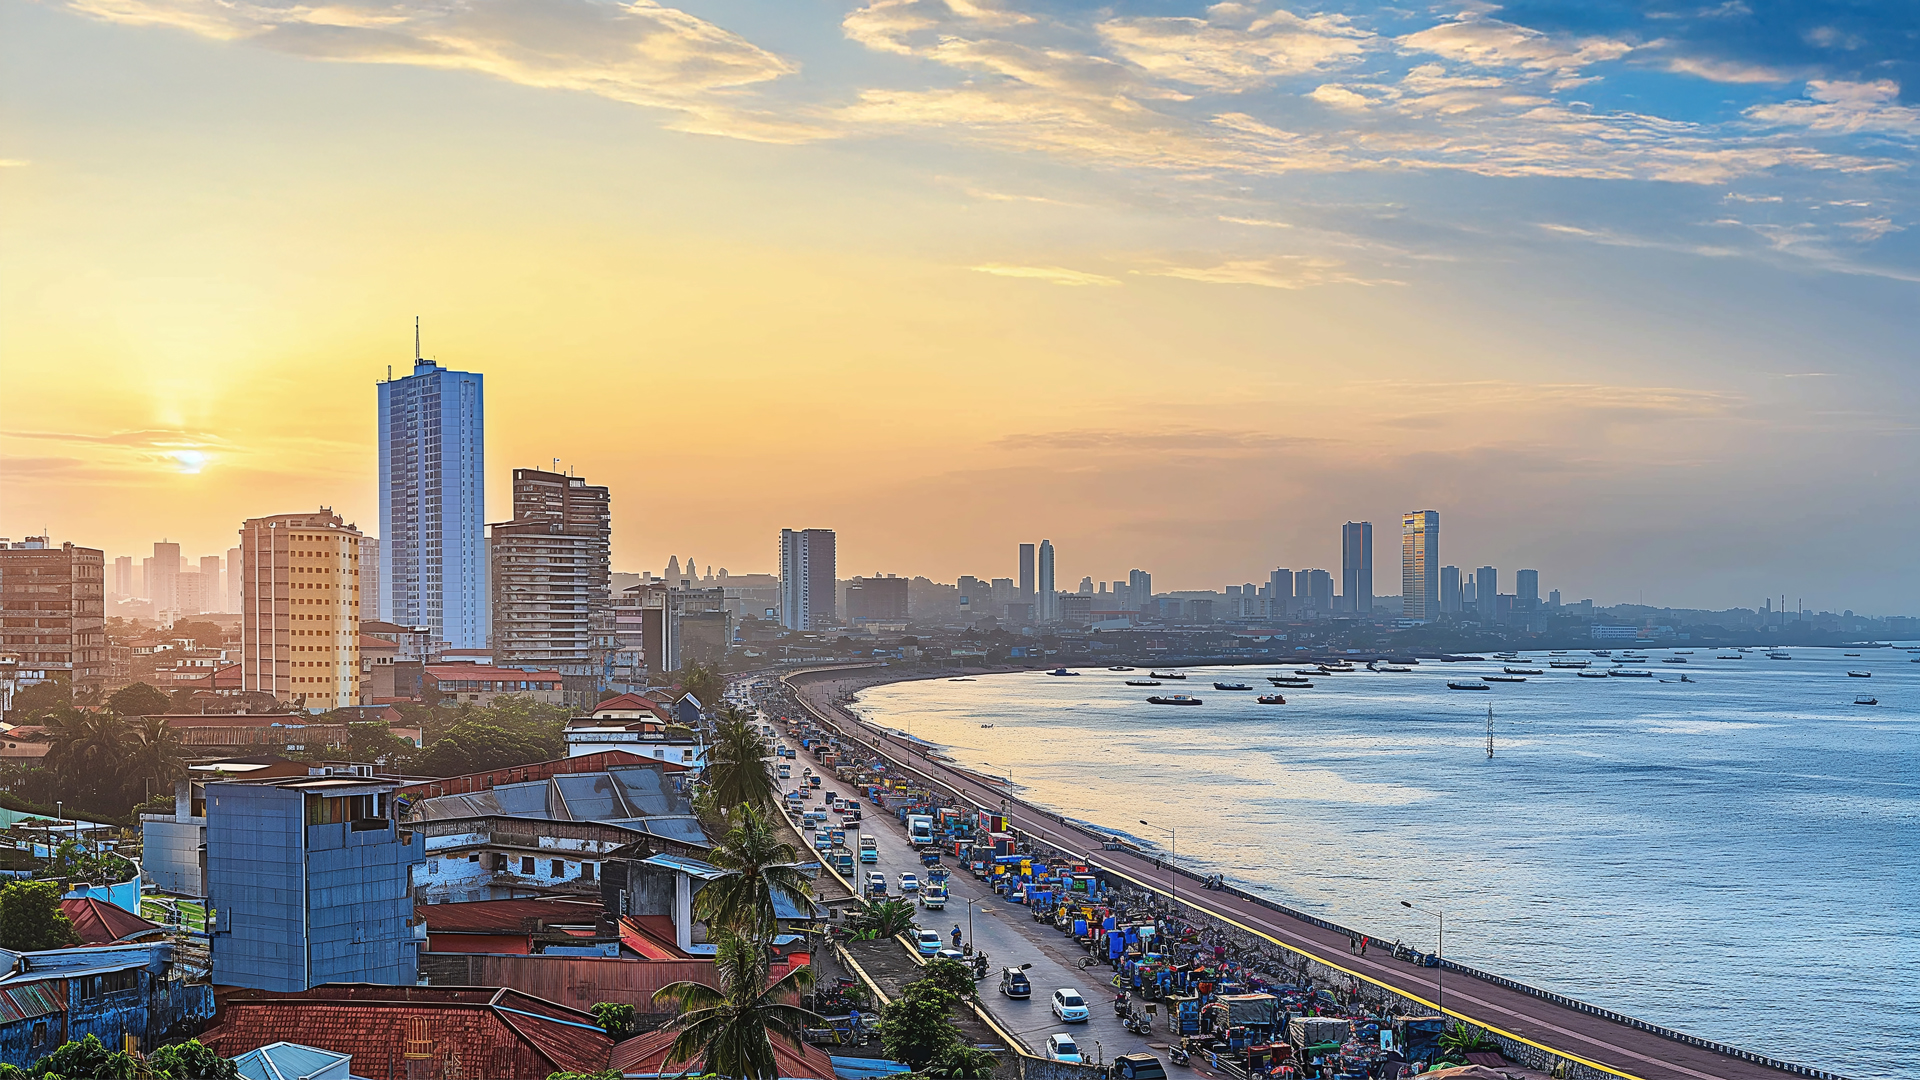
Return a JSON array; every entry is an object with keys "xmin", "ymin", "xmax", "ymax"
[{"xmin": 653, "ymin": 926, "xmax": 814, "ymax": 1080}]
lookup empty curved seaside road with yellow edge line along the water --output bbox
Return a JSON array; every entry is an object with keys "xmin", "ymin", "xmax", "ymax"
[{"xmin": 789, "ymin": 673, "xmax": 1827, "ymax": 1080}]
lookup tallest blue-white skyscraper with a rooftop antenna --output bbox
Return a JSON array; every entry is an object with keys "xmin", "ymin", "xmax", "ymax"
[{"xmin": 380, "ymin": 325, "xmax": 492, "ymax": 650}]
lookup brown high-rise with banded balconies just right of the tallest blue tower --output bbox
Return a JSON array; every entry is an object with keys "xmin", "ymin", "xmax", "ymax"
[{"xmin": 490, "ymin": 469, "xmax": 612, "ymax": 707}]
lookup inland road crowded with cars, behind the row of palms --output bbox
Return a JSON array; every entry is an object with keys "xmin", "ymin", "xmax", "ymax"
[{"xmin": 764, "ymin": 714, "xmax": 1165, "ymax": 1061}]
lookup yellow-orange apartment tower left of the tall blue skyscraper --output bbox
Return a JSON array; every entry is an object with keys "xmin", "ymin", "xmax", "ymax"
[{"xmin": 240, "ymin": 507, "xmax": 361, "ymax": 711}]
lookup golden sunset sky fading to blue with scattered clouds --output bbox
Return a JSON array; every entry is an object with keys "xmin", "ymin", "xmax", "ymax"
[{"xmin": 0, "ymin": 0, "xmax": 1920, "ymax": 613}]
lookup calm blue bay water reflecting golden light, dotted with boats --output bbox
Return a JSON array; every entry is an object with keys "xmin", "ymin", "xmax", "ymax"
[{"xmin": 856, "ymin": 648, "xmax": 1920, "ymax": 1080}]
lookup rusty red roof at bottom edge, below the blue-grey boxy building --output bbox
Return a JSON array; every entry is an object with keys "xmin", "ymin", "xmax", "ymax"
[{"xmin": 200, "ymin": 984, "xmax": 612, "ymax": 1080}]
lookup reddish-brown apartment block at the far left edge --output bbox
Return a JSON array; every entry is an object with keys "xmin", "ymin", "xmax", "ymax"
[{"xmin": 0, "ymin": 536, "xmax": 108, "ymax": 694}]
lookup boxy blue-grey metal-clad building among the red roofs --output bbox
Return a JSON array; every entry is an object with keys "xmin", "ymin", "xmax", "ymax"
[{"xmin": 207, "ymin": 776, "xmax": 426, "ymax": 990}]
